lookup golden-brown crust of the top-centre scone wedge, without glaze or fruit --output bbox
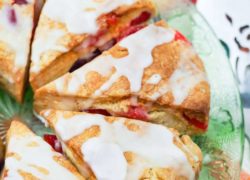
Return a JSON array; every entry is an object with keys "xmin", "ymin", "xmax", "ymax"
[{"xmin": 30, "ymin": 0, "xmax": 155, "ymax": 89}]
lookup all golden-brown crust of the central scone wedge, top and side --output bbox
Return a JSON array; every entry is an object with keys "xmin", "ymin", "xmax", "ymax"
[{"xmin": 34, "ymin": 21, "xmax": 210, "ymax": 134}]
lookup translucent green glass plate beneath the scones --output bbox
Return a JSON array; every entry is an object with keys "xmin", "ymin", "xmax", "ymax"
[{"xmin": 0, "ymin": 0, "xmax": 244, "ymax": 180}]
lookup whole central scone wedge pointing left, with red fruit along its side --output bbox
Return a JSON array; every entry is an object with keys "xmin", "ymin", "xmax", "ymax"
[{"xmin": 35, "ymin": 21, "xmax": 210, "ymax": 133}]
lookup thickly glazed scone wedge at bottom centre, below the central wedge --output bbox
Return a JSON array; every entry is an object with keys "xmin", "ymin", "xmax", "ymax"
[{"xmin": 41, "ymin": 110, "xmax": 202, "ymax": 180}]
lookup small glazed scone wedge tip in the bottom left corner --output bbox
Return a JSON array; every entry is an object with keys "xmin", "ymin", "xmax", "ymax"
[{"xmin": 1, "ymin": 120, "xmax": 84, "ymax": 180}]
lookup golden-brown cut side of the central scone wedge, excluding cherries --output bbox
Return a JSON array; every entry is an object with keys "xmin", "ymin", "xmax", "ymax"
[{"xmin": 34, "ymin": 86, "xmax": 208, "ymax": 134}]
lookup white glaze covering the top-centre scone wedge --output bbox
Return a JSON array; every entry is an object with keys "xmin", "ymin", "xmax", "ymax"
[{"xmin": 30, "ymin": 0, "xmax": 141, "ymax": 74}]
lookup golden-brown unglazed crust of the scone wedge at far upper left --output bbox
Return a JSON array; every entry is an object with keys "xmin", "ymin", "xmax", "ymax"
[{"xmin": 0, "ymin": 1, "xmax": 35, "ymax": 102}]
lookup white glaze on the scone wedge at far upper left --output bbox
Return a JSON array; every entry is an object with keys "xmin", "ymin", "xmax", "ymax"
[{"xmin": 0, "ymin": 0, "xmax": 33, "ymax": 69}]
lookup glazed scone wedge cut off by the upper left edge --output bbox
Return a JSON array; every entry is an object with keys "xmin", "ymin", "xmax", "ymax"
[{"xmin": 0, "ymin": 0, "xmax": 38, "ymax": 102}]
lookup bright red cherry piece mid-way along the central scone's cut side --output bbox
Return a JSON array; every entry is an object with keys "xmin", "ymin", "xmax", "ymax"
[{"xmin": 125, "ymin": 106, "xmax": 148, "ymax": 121}]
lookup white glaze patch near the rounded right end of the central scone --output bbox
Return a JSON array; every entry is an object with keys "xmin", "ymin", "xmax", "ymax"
[{"xmin": 150, "ymin": 48, "xmax": 207, "ymax": 105}]
